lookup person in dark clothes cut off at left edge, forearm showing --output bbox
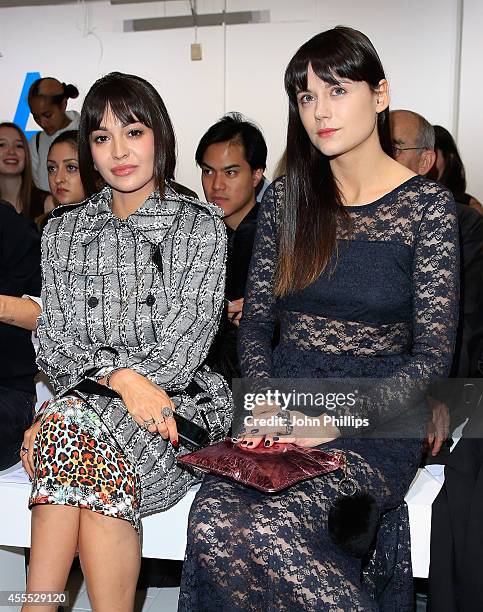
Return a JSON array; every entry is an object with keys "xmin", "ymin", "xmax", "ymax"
[{"xmin": 0, "ymin": 201, "xmax": 40, "ymax": 470}]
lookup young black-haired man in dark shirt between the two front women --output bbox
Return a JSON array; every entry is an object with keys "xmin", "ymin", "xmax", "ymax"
[{"xmin": 195, "ymin": 113, "xmax": 267, "ymax": 383}]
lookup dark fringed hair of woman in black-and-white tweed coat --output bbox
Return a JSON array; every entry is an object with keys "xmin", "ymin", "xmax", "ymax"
[{"xmin": 79, "ymin": 72, "xmax": 176, "ymax": 197}]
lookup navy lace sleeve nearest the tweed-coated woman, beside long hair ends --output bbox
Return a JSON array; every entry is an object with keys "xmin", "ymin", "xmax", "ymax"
[{"xmin": 238, "ymin": 180, "xmax": 283, "ymax": 378}]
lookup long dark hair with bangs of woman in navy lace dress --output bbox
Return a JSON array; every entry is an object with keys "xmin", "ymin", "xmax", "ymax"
[{"xmin": 275, "ymin": 26, "xmax": 392, "ymax": 296}]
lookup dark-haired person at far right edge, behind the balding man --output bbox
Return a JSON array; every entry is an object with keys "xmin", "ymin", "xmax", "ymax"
[{"xmin": 429, "ymin": 125, "xmax": 483, "ymax": 215}]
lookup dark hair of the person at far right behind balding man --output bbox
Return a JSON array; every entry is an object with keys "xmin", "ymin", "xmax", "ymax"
[{"xmin": 431, "ymin": 125, "xmax": 466, "ymax": 202}]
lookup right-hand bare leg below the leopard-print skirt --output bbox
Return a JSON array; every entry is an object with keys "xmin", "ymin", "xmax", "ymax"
[{"xmin": 79, "ymin": 509, "xmax": 141, "ymax": 612}]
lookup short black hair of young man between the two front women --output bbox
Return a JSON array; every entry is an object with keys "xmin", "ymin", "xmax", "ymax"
[{"xmin": 195, "ymin": 113, "xmax": 267, "ymax": 170}]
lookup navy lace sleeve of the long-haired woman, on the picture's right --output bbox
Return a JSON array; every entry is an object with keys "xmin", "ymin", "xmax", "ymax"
[{"xmin": 340, "ymin": 186, "xmax": 459, "ymax": 435}]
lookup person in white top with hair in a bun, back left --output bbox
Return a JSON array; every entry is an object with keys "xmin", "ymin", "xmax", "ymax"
[{"xmin": 28, "ymin": 77, "xmax": 79, "ymax": 191}]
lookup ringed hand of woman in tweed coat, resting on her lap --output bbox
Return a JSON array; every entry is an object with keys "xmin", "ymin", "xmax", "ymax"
[{"xmin": 107, "ymin": 368, "xmax": 178, "ymax": 448}]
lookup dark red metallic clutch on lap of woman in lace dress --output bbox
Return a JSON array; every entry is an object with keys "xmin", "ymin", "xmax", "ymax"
[{"xmin": 178, "ymin": 440, "xmax": 345, "ymax": 493}]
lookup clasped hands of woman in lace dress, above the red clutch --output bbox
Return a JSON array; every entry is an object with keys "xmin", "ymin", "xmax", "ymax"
[{"xmin": 237, "ymin": 405, "xmax": 340, "ymax": 450}]
